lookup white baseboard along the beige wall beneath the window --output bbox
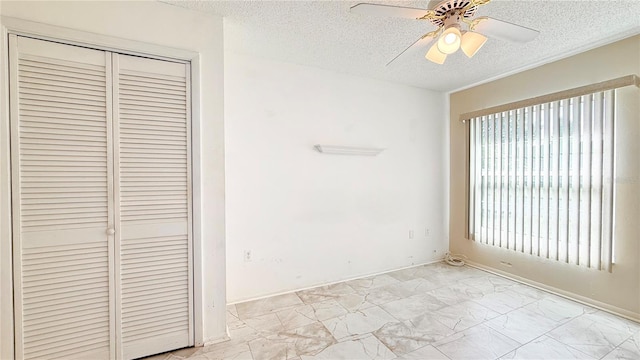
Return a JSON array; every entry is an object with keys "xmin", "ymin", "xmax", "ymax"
[{"xmin": 465, "ymin": 260, "xmax": 640, "ymax": 323}]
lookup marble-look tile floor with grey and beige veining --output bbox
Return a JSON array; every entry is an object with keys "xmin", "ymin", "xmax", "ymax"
[{"xmin": 147, "ymin": 263, "xmax": 640, "ymax": 360}]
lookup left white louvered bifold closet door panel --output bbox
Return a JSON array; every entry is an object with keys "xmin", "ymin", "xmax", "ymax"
[{"xmin": 10, "ymin": 35, "xmax": 115, "ymax": 359}]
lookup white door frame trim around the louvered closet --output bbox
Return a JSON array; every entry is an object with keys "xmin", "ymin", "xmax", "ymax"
[{"xmin": 0, "ymin": 16, "xmax": 205, "ymax": 357}]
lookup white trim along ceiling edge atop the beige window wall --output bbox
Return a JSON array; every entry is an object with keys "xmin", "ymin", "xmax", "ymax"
[{"xmin": 446, "ymin": 27, "xmax": 640, "ymax": 95}]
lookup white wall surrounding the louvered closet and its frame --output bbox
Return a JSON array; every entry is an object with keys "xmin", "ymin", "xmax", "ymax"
[{"xmin": 0, "ymin": 1, "xmax": 226, "ymax": 359}]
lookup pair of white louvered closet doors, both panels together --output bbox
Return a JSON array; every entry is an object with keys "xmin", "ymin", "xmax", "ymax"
[{"xmin": 9, "ymin": 35, "xmax": 194, "ymax": 359}]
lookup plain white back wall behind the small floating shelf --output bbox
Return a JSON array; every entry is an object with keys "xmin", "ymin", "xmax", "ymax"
[{"xmin": 225, "ymin": 52, "xmax": 448, "ymax": 302}]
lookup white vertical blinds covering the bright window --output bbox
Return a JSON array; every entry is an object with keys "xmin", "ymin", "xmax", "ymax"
[{"xmin": 468, "ymin": 90, "xmax": 615, "ymax": 271}]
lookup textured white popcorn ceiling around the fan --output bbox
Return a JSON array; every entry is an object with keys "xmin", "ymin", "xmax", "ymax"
[{"xmin": 166, "ymin": 0, "xmax": 640, "ymax": 91}]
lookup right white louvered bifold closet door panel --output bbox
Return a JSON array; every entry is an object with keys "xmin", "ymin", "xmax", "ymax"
[{"xmin": 113, "ymin": 54, "xmax": 193, "ymax": 359}]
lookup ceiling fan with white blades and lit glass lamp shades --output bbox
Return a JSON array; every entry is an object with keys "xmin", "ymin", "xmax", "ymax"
[{"xmin": 351, "ymin": 0, "xmax": 539, "ymax": 65}]
